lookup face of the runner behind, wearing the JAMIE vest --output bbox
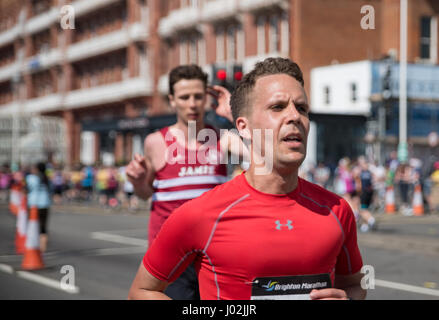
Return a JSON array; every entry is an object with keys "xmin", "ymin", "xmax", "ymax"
[{"xmin": 169, "ymin": 79, "xmax": 206, "ymax": 124}]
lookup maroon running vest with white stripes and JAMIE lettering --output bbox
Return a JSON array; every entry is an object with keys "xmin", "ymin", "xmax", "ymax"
[{"xmin": 148, "ymin": 126, "xmax": 228, "ymax": 245}]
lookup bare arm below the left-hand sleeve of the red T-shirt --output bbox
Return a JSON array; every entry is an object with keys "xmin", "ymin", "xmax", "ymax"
[{"xmin": 128, "ymin": 262, "xmax": 171, "ymax": 300}]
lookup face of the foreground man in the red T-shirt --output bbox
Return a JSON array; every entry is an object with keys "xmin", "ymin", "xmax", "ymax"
[{"xmin": 241, "ymin": 74, "xmax": 309, "ymax": 168}]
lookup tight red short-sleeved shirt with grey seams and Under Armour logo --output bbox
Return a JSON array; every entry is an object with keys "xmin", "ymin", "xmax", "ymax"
[{"xmin": 143, "ymin": 174, "xmax": 363, "ymax": 300}]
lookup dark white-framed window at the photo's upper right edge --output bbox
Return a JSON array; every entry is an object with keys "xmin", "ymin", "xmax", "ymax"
[{"xmin": 420, "ymin": 17, "xmax": 438, "ymax": 63}]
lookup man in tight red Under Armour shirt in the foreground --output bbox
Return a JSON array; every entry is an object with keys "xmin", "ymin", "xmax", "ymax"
[{"xmin": 129, "ymin": 58, "xmax": 366, "ymax": 299}]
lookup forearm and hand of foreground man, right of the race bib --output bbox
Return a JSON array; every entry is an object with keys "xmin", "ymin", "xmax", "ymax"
[{"xmin": 310, "ymin": 272, "xmax": 367, "ymax": 300}]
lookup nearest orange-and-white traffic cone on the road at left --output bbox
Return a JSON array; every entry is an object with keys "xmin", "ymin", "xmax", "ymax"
[{"xmin": 21, "ymin": 207, "xmax": 44, "ymax": 270}]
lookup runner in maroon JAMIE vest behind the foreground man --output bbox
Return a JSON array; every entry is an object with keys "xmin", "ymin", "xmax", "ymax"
[{"xmin": 126, "ymin": 65, "xmax": 246, "ymax": 299}]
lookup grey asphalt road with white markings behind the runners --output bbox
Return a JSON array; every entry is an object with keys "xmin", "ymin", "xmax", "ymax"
[{"xmin": 0, "ymin": 205, "xmax": 439, "ymax": 300}]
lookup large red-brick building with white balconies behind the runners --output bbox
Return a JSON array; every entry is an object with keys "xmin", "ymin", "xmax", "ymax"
[{"xmin": 0, "ymin": 0, "xmax": 439, "ymax": 165}]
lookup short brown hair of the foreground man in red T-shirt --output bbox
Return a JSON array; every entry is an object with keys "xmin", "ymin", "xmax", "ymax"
[{"xmin": 230, "ymin": 58, "xmax": 304, "ymax": 121}]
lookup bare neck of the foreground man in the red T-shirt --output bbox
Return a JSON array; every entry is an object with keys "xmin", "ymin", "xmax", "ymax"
[{"xmin": 245, "ymin": 165, "xmax": 299, "ymax": 194}]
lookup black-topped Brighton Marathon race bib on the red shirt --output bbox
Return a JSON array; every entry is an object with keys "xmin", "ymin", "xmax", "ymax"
[{"xmin": 251, "ymin": 273, "xmax": 332, "ymax": 300}]
